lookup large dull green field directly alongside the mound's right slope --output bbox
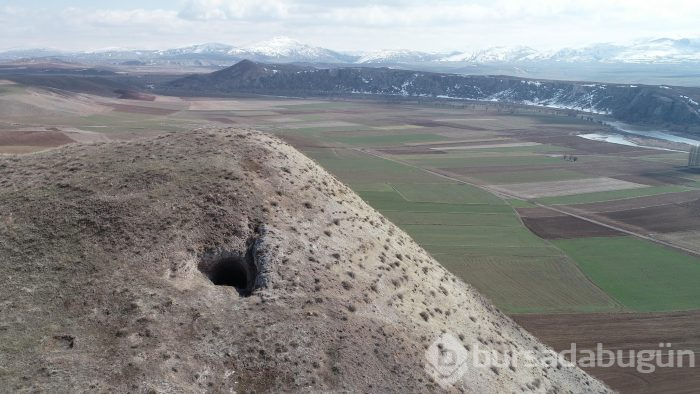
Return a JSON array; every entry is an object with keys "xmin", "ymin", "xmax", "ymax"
[{"xmin": 348, "ymin": 177, "xmax": 622, "ymax": 313}]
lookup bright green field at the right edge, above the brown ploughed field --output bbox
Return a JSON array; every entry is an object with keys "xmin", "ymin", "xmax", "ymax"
[{"xmin": 554, "ymin": 237, "xmax": 700, "ymax": 312}]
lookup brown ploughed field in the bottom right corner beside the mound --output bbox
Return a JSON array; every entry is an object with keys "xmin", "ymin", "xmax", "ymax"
[{"xmin": 513, "ymin": 311, "xmax": 700, "ymax": 394}]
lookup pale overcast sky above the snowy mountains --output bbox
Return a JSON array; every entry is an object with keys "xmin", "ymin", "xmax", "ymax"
[{"xmin": 0, "ymin": 0, "xmax": 700, "ymax": 51}]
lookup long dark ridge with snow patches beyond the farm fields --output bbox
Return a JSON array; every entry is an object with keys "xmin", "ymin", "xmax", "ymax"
[{"xmin": 166, "ymin": 60, "xmax": 700, "ymax": 130}]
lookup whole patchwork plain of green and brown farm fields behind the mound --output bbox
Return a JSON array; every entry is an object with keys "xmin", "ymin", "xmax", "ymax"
[{"xmin": 0, "ymin": 85, "xmax": 700, "ymax": 392}]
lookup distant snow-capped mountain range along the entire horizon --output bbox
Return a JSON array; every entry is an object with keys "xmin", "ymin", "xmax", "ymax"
[{"xmin": 0, "ymin": 37, "xmax": 700, "ymax": 66}]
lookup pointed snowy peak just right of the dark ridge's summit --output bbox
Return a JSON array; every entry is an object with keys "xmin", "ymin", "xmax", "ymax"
[{"xmin": 228, "ymin": 37, "xmax": 353, "ymax": 63}]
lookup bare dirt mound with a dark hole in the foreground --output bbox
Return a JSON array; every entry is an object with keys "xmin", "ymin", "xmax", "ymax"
[{"xmin": 0, "ymin": 129, "xmax": 607, "ymax": 393}]
